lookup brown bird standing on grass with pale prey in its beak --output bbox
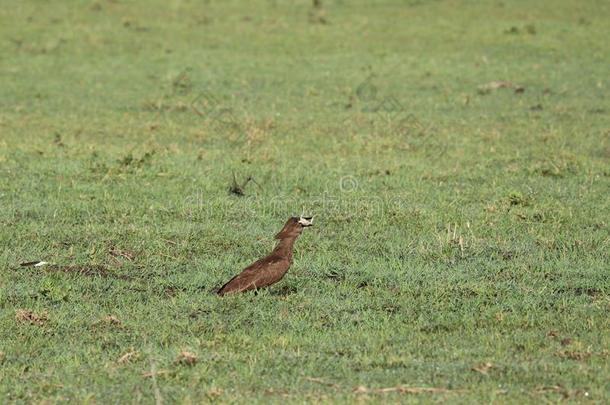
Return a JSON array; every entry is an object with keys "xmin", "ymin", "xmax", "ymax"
[{"xmin": 218, "ymin": 216, "xmax": 313, "ymax": 295}]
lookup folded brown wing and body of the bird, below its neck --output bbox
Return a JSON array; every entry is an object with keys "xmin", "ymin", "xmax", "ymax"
[{"xmin": 218, "ymin": 257, "xmax": 288, "ymax": 295}]
